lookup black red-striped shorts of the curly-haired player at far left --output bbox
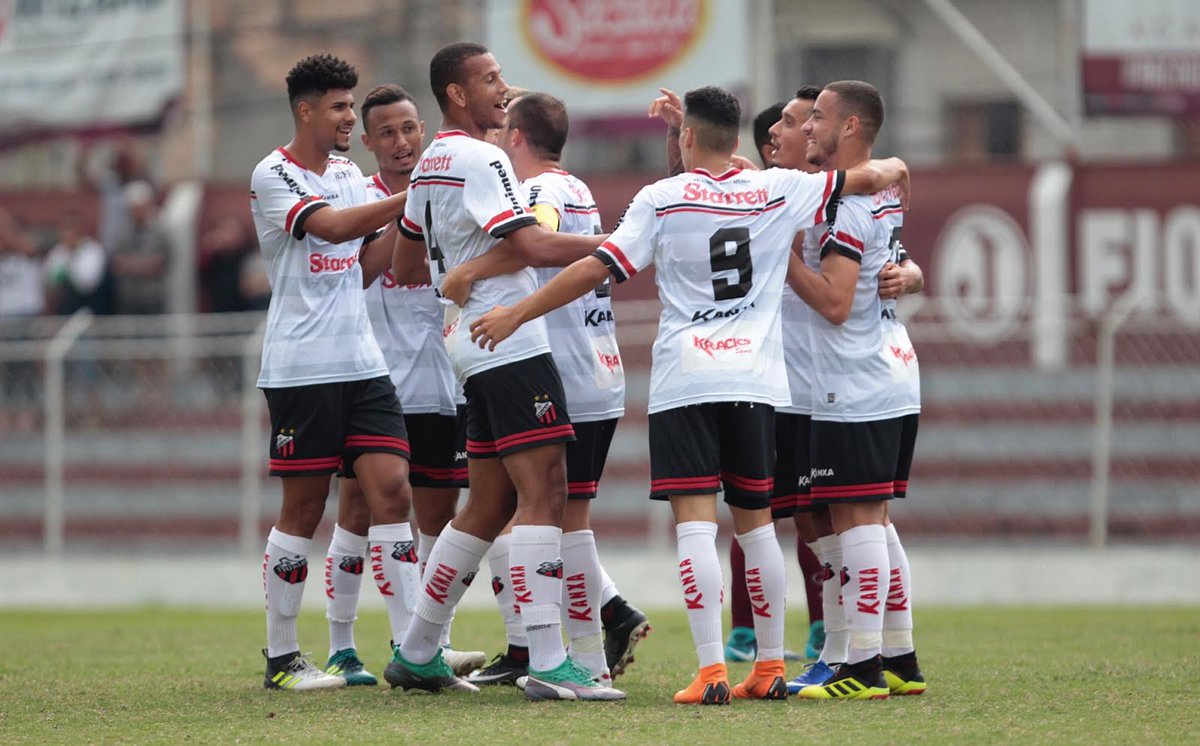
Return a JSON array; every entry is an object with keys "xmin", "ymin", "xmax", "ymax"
[{"xmin": 263, "ymin": 375, "xmax": 409, "ymax": 476}]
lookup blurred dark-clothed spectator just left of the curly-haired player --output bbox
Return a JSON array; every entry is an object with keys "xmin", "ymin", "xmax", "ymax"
[{"xmin": 200, "ymin": 215, "xmax": 271, "ymax": 313}]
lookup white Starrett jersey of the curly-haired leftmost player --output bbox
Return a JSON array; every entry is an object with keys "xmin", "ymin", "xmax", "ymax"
[{"xmin": 250, "ymin": 148, "xmax": 388, "ymax": 389}]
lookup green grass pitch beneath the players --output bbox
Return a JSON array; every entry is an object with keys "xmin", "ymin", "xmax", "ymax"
[{"xmin": 0, "ymin": 608, "xmax": 1200, "ymax": 744}]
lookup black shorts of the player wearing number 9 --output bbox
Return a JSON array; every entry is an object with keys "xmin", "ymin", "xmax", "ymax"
[{"xmin": 649, "ymin": 402, "xmax": 775, "ymax": 510}]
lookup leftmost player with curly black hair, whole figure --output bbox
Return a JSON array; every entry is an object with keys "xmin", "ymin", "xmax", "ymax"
[{"xmin": 250, "ymin": 55, "xmax": 410, "ymax": 690}]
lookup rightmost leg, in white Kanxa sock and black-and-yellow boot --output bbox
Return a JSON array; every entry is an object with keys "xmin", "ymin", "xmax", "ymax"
[{"xmin": 883, "ymin": 414, "xmax": 925, "ymax": 694}]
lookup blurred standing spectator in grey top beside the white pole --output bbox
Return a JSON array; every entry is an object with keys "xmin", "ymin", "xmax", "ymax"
[{"xmin": 109, "ymin": 181, "xmax": 170, "ymax": 314}]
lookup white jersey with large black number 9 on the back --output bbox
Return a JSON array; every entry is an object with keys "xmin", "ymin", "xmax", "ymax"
[{"xmin": 595, "ymin": 168, "xmax": 845, "ymax": 414}]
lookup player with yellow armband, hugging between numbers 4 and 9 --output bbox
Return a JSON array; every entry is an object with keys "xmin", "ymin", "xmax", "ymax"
[{"xmin": 443, "ymin": 92, "xmax": 649, "ymax": 684}]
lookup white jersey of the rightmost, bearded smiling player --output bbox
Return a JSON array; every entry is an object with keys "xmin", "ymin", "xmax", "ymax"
[{"xmin": 812, "ymin": 187, "xmax": 920, "ymax": 422}]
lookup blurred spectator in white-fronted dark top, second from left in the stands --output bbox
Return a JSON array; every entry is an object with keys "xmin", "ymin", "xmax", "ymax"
[{"xmin": 43, "ymin": 211, "xmax": 113, "ymax": 314}]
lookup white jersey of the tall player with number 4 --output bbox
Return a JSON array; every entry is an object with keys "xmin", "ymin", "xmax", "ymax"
[{"xmin": 400, "ymin": 130, "xmax": 550, "ymax": 383}]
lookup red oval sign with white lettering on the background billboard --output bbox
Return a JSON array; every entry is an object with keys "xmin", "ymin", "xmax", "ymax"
[{"xmin": 522, "ymin": 0, "xmax": 707, "ymax": 84}]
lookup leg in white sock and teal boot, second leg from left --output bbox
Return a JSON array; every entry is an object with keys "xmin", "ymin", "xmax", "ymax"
[{"xmin": 325, "ymin": 475, "xmax": 379, "ymax": 686}]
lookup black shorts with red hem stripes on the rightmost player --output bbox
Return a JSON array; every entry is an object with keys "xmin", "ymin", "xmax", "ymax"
[{"xmin": 811, "ymin": 415, "xmax": 918, "ymax": 505}]
